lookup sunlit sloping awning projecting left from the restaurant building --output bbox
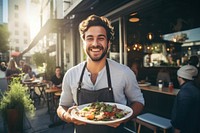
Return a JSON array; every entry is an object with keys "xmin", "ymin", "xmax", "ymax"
[{"xmin": 21, "ymin": 19, "xmax": 68, "ymax": 55}]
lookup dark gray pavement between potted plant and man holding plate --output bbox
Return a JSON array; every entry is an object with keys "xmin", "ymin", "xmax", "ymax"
[{"xmin": 0, "ymin": 102, "xmax": 73, "ymax": 133}]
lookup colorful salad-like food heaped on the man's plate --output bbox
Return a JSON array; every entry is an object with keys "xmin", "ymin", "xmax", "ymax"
[{"xmin": 77, "ymin": 102, "xmax": 130, "ymax": 121}]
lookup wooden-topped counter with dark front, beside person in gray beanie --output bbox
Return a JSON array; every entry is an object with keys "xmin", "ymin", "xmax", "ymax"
[{"xmin": 140, "ymin": 86, "xmax": 179, "ymax": 119}]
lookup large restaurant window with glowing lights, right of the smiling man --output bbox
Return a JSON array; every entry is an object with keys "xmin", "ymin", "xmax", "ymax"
[{"xmin": 126, "ymin": 0, "xmax": 200, "ymax": 67}]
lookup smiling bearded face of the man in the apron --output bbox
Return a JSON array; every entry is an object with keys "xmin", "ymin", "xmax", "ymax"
[{"xmin": 84, "ymin": 26, "xmax": 110, "ymax": 61}]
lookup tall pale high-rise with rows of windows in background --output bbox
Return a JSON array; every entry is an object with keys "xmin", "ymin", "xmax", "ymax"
[{"xmin": 8, "ymin": 0, "xmax": 30, "ymax": 56}]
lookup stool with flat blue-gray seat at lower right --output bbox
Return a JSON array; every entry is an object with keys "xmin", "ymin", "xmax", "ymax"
[{"xmin": 135, "ymin": 113, "xmax": 172, "ymax": 133}]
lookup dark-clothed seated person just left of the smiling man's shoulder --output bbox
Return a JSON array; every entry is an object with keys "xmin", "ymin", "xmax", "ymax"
[{"xmin": 51, "ymin": 66, "xmax": 63, "ymax": 88}]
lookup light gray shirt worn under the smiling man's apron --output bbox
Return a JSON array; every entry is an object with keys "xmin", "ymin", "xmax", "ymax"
[{"xmin": 59, "ymin": 59, "xmax": 144, "ymax": 107}]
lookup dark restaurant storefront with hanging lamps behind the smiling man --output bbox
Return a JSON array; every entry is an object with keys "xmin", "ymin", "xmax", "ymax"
[{"xmin": 62, "ymin": 0, "xmax": 200, "ymax": 87}]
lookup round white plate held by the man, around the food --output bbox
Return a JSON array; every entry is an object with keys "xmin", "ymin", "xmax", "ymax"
[{"xmin": 71, "ymin": 102, "xmax": 133, "ymax": 125}]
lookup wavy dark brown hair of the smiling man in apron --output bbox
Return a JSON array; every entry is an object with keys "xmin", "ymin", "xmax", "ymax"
[{"xmin": 79, "ymin": 15, "xmax": 114, "ymax": 41}]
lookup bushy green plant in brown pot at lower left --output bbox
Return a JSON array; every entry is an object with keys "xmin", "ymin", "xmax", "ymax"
[{"xmin": 0, "ymin": 77, "xmax": 35, "ymax": 133}]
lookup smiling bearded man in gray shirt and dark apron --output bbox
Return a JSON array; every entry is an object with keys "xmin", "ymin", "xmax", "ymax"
[{"xmin": 57, "ymin": 15, "xmax": 144, "ymax": 133}]
